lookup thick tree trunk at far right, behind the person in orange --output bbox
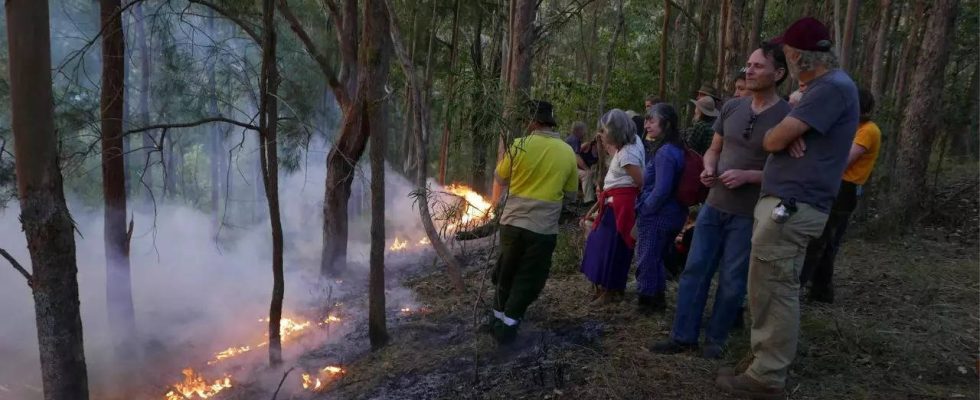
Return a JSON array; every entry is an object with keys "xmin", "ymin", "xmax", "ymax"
[{"xmin": 885, "ymin": 0, "xmax": 958, "ymax": 227}]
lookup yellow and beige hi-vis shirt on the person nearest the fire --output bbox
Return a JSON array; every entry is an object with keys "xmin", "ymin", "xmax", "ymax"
[{"xmin": 496, "ymin": 131, "xmax": 578, "ymax": 234}]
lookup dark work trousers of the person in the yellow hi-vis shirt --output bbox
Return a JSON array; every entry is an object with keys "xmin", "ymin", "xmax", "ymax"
[{"xmin": 492, "ymin": 225, "xmax": 558, "ymax": 320}]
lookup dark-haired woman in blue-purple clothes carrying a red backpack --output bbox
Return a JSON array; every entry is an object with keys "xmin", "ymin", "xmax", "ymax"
[{"xmin": 636, "ymin": 104, "xmax": 684, "ymax": 313}]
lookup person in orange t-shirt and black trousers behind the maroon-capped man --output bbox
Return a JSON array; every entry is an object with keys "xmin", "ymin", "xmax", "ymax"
[{"xmin": 800, "ymin": 89, "xmax": 881, "ymax": 303}]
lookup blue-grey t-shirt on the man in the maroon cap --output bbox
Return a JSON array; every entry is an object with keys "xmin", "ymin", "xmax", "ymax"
[{"xmin": 762, "ymin": 69, "xmax": 861, "ymax": 212}]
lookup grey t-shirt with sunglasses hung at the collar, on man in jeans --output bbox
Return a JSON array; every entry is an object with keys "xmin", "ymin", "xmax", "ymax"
[{"xmin": 706, "ymin": 97, "xmax": 790, "ymax": 217}]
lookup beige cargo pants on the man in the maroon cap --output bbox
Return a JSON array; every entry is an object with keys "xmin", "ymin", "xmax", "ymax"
[{"xmin": 745, "ymin": 196, "xmax": 827, "ymax": 387}]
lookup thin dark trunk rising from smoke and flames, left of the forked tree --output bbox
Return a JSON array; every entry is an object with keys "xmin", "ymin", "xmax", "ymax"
[{"xmin": 259, "ymin": 0, "xmax": 285, "ymax": 366}]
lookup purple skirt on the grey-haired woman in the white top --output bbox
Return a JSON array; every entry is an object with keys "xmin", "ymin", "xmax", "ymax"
[{"xmin": 582, "ymin": 207, "xmax": 633, "ymax": 290}]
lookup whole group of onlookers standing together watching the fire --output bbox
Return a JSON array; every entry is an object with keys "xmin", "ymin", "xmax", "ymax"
[{"xmin": 485, "ymin": 18, "xmax": 881, "ymax": 398}]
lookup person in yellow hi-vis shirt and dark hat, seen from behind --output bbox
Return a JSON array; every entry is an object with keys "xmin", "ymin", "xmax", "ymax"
[{"xmin": 486, "ymin": 101, "xmax": 578, "ymax": 344}]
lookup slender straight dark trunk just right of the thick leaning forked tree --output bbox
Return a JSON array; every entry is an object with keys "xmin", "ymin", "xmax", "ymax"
[{"xmin": 366, "ymin": 0, "xmax": 392, "ymax": 349}]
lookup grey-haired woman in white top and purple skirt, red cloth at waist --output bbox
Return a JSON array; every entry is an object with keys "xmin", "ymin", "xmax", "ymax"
[{"xmin": 581, "ymin": 106, "xmax": 656, "ymax": 305}]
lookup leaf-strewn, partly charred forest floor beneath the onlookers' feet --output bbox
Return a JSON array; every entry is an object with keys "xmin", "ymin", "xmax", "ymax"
[{"xmin": 315, "ymin": 173, "xmax": 980, "ymax": 399}]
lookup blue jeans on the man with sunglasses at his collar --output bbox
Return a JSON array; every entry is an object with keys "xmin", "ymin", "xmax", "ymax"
[{"xmin": 670, "ymin": 205, "xmax": 753, "ymax": 346}]
